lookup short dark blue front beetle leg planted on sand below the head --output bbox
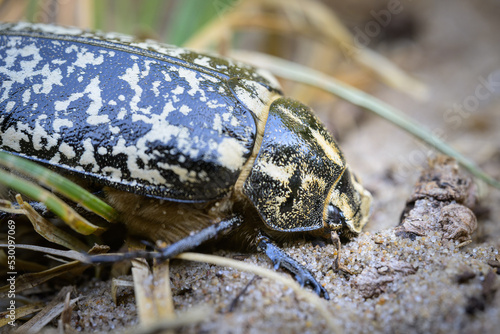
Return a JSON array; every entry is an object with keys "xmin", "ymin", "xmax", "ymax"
[{"xmin": 257, "ymin": 234, "xmax": 330, "ymax": 300}]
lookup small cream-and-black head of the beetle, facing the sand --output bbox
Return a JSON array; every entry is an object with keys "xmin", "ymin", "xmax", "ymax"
[{"xmin": 325, "ymin": 167, "xmax": 372, "ymax": 234}]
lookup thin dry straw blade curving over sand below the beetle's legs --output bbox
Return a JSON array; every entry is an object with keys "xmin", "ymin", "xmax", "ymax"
[{"xmin": 175, "ymin": 253, "xmax": 340, "ymax": 333}]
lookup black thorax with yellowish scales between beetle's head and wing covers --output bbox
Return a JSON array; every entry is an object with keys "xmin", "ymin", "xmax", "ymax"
[{"xmin": 243, "ymin": 98, "xmax": 356, "ymax": 232}]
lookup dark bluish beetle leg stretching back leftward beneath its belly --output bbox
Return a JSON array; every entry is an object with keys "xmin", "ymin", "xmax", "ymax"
[{"xmin": 88, "ymin": 215, "xmax": 243, "ymax": 263}]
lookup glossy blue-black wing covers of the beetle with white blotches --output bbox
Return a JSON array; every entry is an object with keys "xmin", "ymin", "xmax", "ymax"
[{"xmin": 0, "ymin": 23, "xmax": 278, "ymax": 201}]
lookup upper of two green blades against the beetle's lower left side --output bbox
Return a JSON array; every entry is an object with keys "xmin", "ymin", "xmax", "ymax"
[{"xmin": 0, "ymin": 152, "xmax": 118, "ymax": 222}]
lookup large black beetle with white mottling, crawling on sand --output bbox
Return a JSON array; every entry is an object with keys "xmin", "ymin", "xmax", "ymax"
[{"xmin": 0, "ymin": 23, "xmax": 371, "ymax": 297}]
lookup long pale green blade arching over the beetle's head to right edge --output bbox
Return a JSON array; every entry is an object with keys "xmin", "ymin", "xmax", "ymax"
[{"xmin": 235, "ymin": 52, "xmax": 500, "ymax": 189}]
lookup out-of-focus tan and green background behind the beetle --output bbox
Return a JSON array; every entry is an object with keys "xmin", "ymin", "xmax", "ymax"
[{"xmin": 0, "ymin": 0, "xmax": 500, "ymax": 238}]
